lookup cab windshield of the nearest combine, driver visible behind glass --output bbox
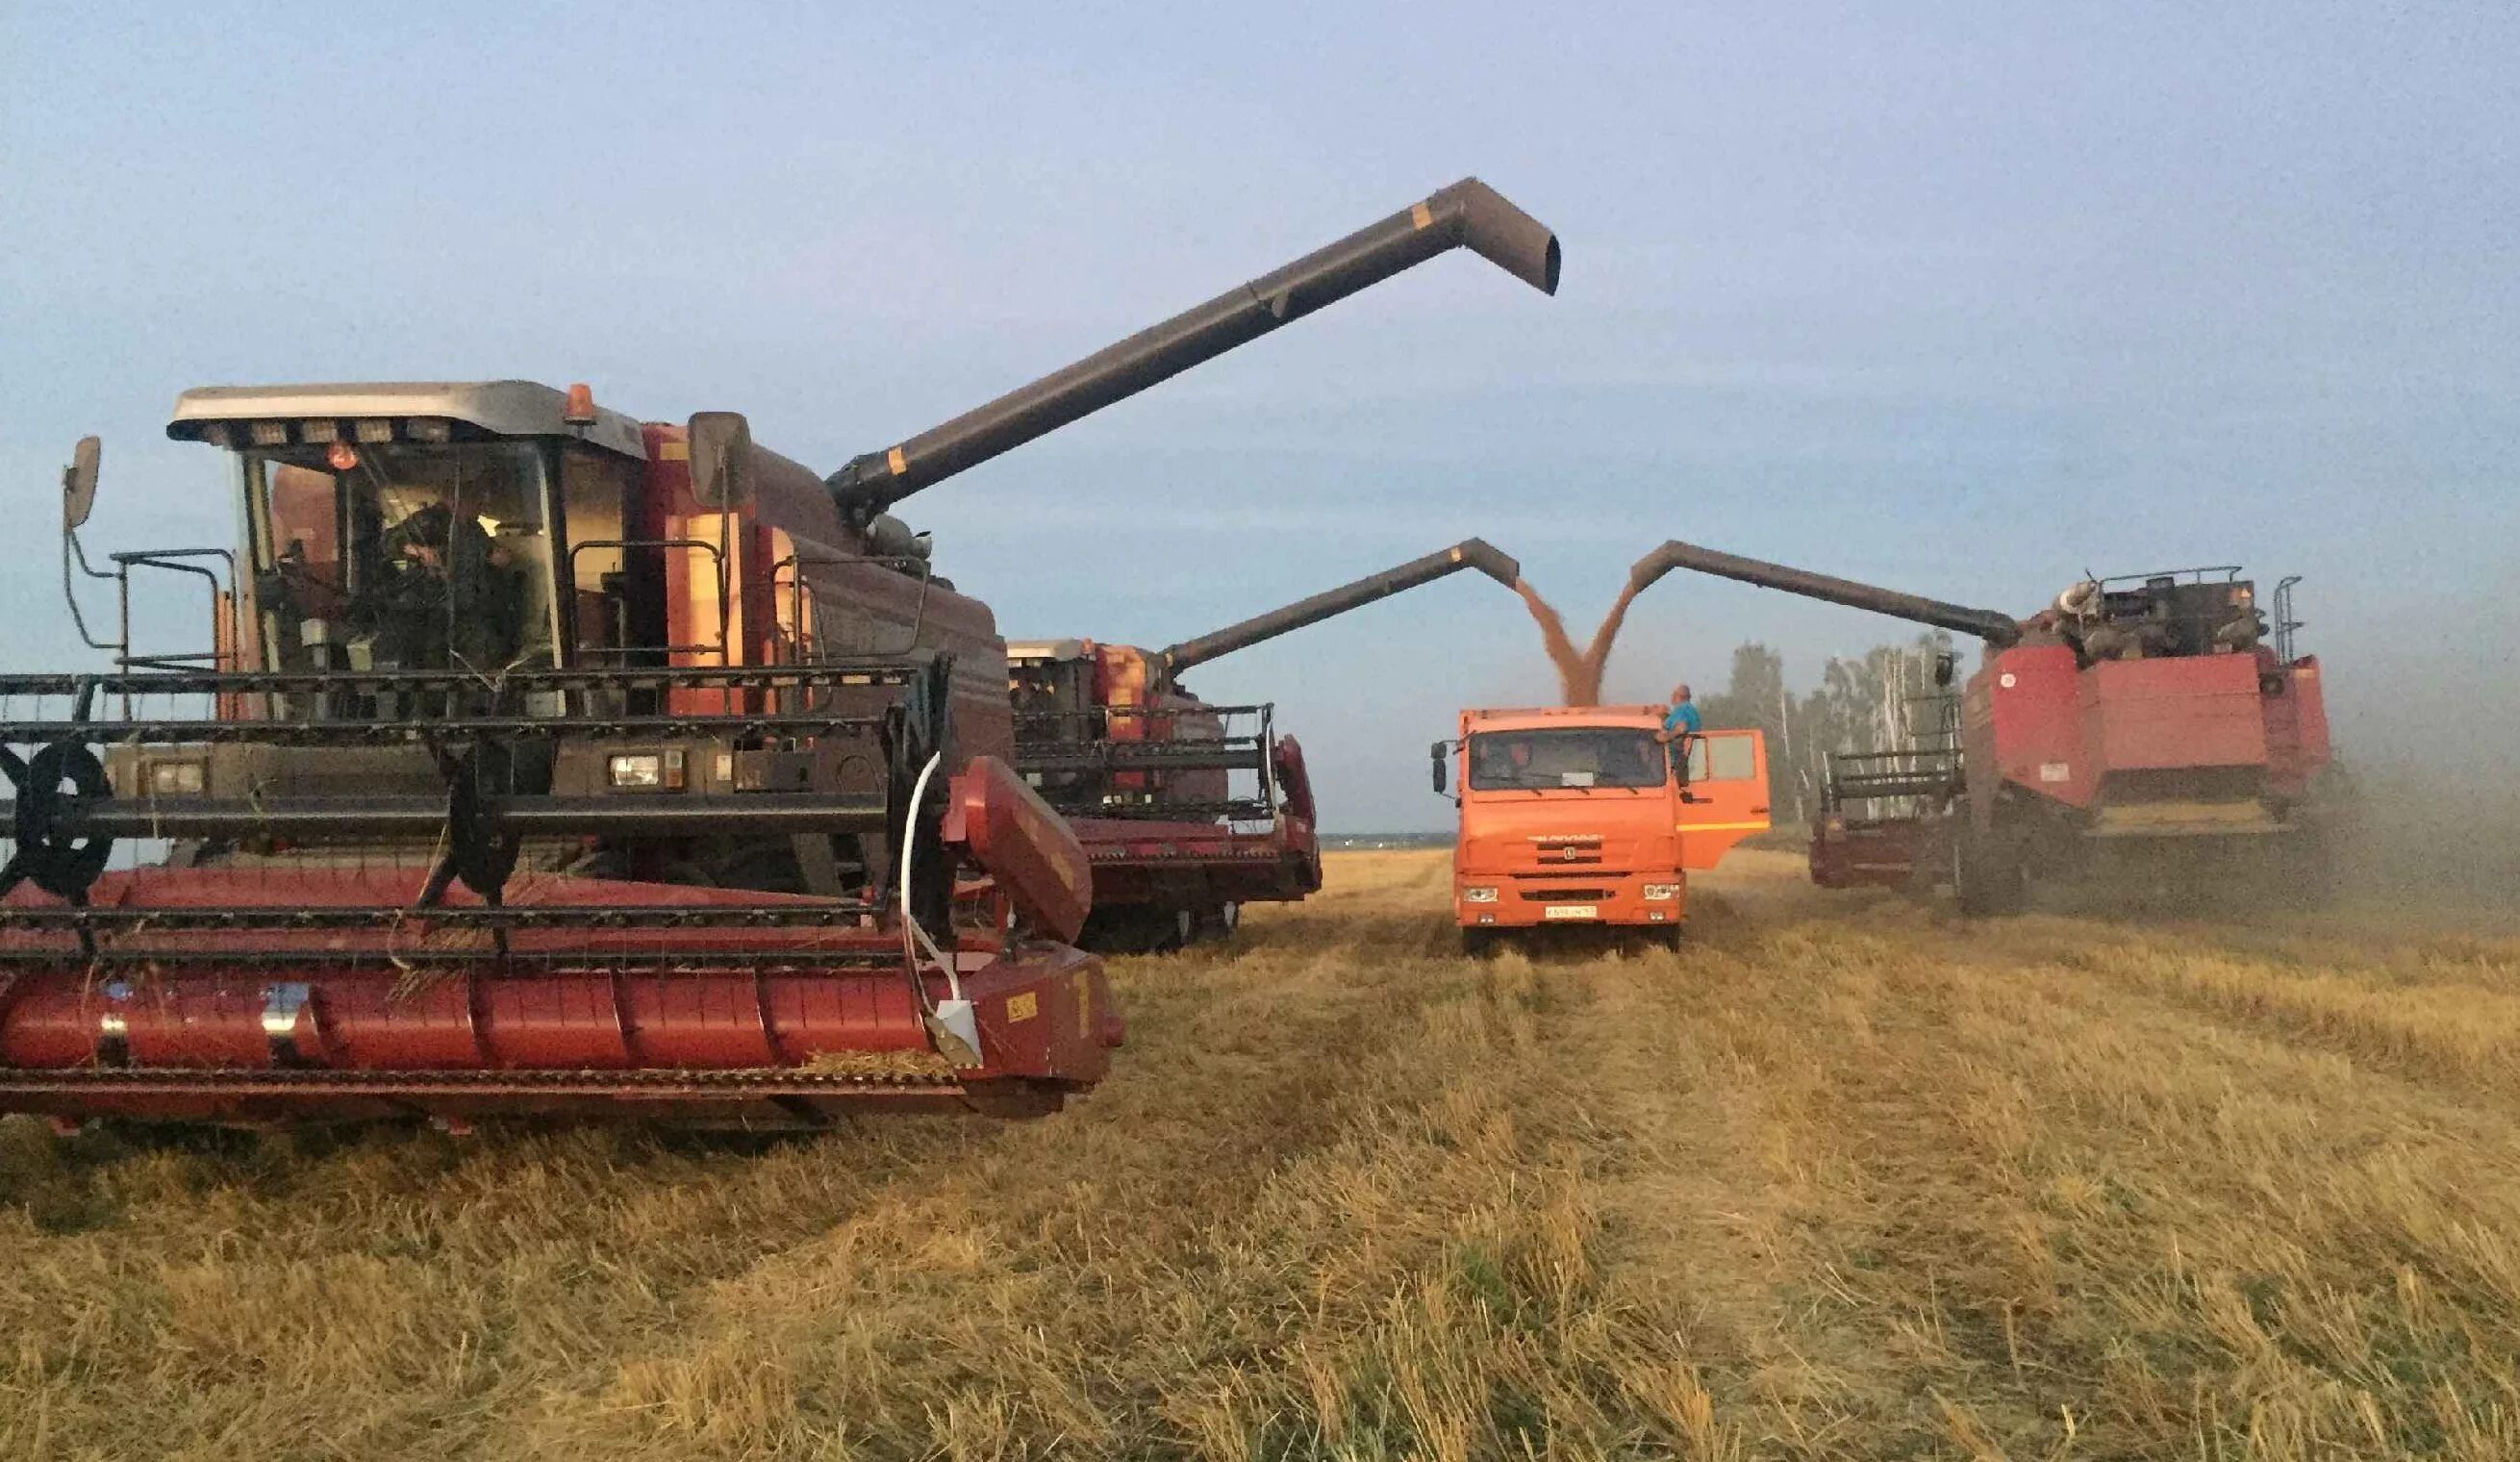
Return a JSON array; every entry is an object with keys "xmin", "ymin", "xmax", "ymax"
[{"xmin": 244, "ymin": 441, "xmax": 554, "ymax": 675}]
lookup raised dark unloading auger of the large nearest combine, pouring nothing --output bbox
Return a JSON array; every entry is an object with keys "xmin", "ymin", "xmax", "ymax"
[{"xmin": 829, "ymin": 179, "xmax": 1557, "ymax": 521}]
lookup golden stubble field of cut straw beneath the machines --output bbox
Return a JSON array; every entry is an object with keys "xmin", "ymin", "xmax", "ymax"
[{"xmin": 0, "ymin": 852, "xmax": 2520, "ymax": 1462}]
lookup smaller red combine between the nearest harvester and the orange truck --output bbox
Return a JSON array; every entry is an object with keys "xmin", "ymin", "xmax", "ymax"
[{"xmin": 1008, "ymin": 540, "xmax": 1522, "ymax": 950}]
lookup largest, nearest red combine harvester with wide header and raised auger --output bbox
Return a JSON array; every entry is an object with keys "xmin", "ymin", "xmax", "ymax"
[{"xmin": 0, "ymin": 182, "xmax": 1557, "ymax": 1126}]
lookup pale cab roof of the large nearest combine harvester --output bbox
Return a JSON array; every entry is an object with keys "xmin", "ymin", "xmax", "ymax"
[{"xmin": 166, "ymin": 381, "xmax": 647, "ymax": 459}]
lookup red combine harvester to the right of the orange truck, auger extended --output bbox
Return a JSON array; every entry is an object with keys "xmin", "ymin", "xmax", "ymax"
[{"xmin": 1630, "ymin": 542, "xmax": 2333, "ymax": 913}]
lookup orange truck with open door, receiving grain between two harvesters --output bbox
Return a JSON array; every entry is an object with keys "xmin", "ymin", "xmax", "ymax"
[{"xmin": 1431, "ymin": 706, "xmax": 1767, "ymax": 953}]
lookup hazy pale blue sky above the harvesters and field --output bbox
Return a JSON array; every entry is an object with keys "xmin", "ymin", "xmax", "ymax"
[{"xmin": 0, "ymin": 0, "xmax": 2520, "ymax": 829}]
